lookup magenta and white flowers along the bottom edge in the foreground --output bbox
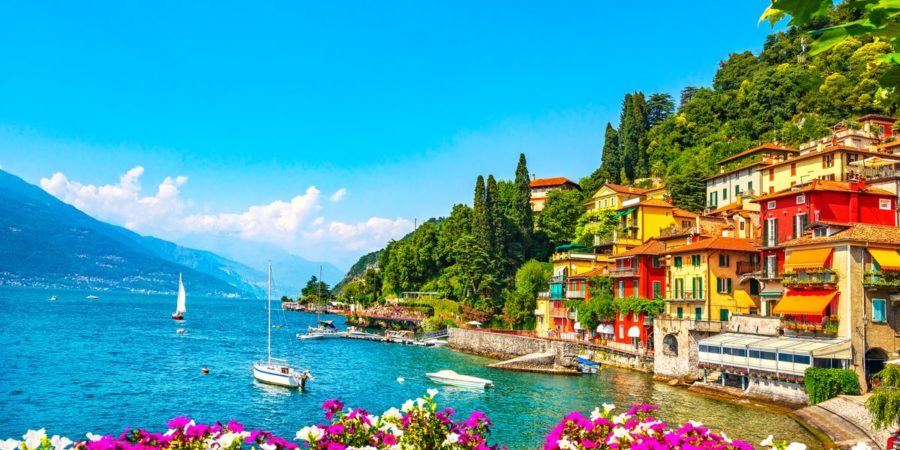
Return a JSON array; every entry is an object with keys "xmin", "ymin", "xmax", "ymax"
[{"xmin": 0, "ymin": 389, "xmax": 840, "ymax": 450}]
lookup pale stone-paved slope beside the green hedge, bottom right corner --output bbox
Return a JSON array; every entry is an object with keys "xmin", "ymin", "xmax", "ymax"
[{"xmin": 794, "ymin": 395, "xmax": 887, "ymax": 450}]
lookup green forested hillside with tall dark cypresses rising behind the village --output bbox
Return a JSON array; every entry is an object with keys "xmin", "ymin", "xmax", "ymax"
[{"xmin": 336, "ymin": 0, "xmax": 897, "ymax": 322}]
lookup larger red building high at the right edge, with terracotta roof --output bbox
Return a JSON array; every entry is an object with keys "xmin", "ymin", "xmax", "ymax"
[{"xmin": 755, "ymin": 180, "xmax": 897, "ymax": 314}]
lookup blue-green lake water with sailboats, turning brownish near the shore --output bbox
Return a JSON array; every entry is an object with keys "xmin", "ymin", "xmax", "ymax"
[{"xmin": 0, "ymin": 288, "xmax": 819, "ymax": 449}]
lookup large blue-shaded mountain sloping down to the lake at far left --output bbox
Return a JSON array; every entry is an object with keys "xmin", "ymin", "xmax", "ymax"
[{"xmin": 0, "ymin": 170, "xmax": 265, "ymax": 296}]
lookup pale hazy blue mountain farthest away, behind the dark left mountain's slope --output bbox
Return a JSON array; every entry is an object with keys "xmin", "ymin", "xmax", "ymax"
[{"xmin": 178, "ymin": 235, "xmax": 344, "ymax": 297}]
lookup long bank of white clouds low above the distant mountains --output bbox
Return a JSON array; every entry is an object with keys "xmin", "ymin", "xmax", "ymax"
[{"xmin": 40, "ymin": 166, "xmax": 412, "ymax": 262}]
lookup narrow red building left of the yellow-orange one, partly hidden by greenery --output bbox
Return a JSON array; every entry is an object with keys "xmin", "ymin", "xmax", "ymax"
[{"xmin": 609, "ymin": 238, "xmax": 666, "ymax": 348}]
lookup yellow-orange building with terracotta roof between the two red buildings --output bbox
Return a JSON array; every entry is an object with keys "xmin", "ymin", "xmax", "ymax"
[{"xmin": 665, "ymin": 237, "xmax": 759, "ymax": 321}]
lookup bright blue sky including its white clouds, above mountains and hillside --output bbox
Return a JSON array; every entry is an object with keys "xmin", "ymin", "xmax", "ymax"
[{"xmin": 0, "ymin": 0, "xmax": 771, "ymax": 267}]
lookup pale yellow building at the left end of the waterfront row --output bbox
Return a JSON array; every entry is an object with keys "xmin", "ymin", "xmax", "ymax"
[{"xmin": 534, "ymin": 244, "xmax": 606, "ymax": 337}]
